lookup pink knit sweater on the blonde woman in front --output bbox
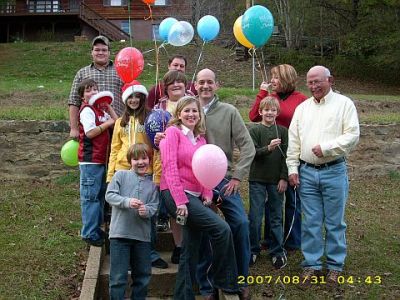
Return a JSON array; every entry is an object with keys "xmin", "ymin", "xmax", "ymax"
[{"xmin": 160, "ymin": 126, "xmax": 212, "ymax": 206}]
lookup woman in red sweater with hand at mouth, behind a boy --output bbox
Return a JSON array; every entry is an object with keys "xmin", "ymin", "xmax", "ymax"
[{"xmin": 249, "ymin": 64, "xmax": 307, "ymax": 254}]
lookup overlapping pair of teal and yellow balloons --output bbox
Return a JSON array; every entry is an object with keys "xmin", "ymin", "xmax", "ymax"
[{"xmin": 233, "ymin": 5, "xmax": 274, "ymax": 48}]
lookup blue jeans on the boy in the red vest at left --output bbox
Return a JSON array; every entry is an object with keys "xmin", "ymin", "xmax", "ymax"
[{"xmin": 79, "ymin": 164, "xmax": 106, "ymax": 241}]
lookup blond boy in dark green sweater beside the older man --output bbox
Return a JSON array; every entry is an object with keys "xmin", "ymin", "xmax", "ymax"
[{"xmin": 249, "ymin": 96, "xmax": 288, "ymax": 269}]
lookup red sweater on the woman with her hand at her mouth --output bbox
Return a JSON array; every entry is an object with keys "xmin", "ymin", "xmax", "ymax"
[{"xmin": 249, "ymin": 90, "xmax": 307, "ymax": 128}]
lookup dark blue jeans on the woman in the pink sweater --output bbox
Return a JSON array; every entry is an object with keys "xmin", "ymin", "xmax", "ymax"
[{"xmin": 161, "ymin": 190, "xmax": 238, "ymax": 300}]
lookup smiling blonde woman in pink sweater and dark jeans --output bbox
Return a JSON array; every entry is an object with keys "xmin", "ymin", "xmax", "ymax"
[{"xmin": 160, "ymin": 96, "xmax": 239, "ymax": 300}]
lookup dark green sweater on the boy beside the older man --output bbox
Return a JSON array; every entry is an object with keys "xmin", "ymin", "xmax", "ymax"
[{"xmin": 249, "ymin": 124, "xmax": 288, "ymax": 184}]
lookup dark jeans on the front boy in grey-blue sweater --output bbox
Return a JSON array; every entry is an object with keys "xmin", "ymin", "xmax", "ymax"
[{"xmin": 109, "ymin": 238, "xmax": 151, "ymax": 300}]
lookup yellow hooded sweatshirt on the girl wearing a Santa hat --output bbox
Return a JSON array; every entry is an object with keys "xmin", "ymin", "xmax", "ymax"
[{"xmin": 107, "ymin": 117, "xmax": 153, "ymax": 182}]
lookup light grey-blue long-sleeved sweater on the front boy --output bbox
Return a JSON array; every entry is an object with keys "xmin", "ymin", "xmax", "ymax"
[{"xmin": 106, "ymin": 170, "xmax": 159, "ymax": 242}]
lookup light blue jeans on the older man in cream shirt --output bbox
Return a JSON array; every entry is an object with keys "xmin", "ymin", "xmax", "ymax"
[{"xmin": 299, "ymin": 162, "xmax": 349, "ymax": 271}]
